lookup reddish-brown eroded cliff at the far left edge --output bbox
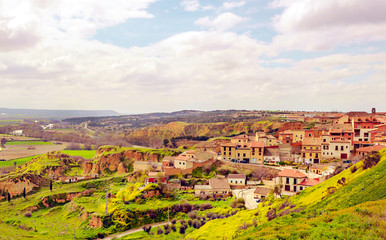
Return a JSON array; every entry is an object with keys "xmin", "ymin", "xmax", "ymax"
[{"xmin": 0, "ymin": 174, "xmax": 49, "ymax": 200}]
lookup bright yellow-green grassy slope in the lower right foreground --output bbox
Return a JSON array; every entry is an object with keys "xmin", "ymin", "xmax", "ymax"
[{"xmin": 186, "ymin": 150, "xmax": 386, "ymax": 239}]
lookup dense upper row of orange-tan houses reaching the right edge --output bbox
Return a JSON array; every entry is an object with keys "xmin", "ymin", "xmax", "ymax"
[{"xmin": 221, "ymin": 110, "xmax": 386, "ymax": 165}]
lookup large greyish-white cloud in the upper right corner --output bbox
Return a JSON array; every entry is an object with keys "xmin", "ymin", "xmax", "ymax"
[{"xmin": 273, "ymin": 0, "xmax": 386, "ymax": 52}]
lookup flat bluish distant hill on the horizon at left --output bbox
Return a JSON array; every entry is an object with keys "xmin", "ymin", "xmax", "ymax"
[{"xmin": 0, "ymin": 108, "xmax": 119, "ymax": 119}]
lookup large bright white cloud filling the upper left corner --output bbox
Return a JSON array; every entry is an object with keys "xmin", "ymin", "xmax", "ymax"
[{"xmin": 0, "ymin": 0, "xmax": 156, "ymax": 51}]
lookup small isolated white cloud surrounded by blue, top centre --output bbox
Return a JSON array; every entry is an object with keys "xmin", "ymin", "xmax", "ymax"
[{"xmin": 194, "ymin": 12, "xmax": 247, "ymax": 31}]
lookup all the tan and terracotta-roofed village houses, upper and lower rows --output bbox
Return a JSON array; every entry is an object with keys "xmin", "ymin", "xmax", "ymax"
[{"xmin": 142, "ymin": 110, "xmax": 386, "ymax": 202}]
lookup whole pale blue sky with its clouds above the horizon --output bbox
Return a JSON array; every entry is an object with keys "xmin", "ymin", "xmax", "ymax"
[{"xmin": 0, "ymin": 0, "xmax": 386, "ymax": 114}]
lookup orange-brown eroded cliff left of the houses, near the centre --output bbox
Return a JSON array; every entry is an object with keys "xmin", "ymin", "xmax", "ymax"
[{"xmin": 82, "ymin": 147, "xmax": 163, "ymax": 175}]
